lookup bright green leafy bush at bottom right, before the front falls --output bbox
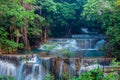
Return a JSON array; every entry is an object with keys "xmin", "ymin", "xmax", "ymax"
[{"xmin": 71, "ymin": 69, "xmax": 120, "ymax": 80}]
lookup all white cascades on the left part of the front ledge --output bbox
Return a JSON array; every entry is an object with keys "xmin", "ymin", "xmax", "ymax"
[{"xmin": 0, "ymin": 55, "xmax": 50, "ymax": 80}]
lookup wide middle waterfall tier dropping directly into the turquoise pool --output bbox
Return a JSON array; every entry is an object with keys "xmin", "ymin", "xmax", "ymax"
[{"xmin": 39, "ymin": 39, "xmax": 105, "ymax": 51}]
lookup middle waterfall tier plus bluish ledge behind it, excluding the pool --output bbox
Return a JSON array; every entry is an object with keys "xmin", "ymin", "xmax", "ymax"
[{"xmin": 39, "ymin": 35, "xmax": 105, "ymax": 51}]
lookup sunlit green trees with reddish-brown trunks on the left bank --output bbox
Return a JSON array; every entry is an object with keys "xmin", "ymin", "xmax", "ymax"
[{"xmin": 0, "ymin": 0, "xmax": 44, "ymax": 52}]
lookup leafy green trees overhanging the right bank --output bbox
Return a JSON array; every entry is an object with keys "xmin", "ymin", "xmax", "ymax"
[{"xmin": 81, "ymin": 0, "xmax": 120, "ymax": 59}]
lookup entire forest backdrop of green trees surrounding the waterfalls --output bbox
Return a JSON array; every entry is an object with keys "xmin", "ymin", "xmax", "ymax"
[{"xmin": 0, "ymin": 0, "xmax": 120, "ymax": 59}]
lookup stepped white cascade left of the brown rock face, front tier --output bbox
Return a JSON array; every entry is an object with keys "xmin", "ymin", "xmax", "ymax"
[{"xmin": 25, "ymin": 55, "xmax": 50, "ymax": 80}]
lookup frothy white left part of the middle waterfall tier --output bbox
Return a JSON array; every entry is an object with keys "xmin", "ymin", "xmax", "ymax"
[{"xmin": 38, "ymin": 39, "xmax": 79, "ymax": 52}]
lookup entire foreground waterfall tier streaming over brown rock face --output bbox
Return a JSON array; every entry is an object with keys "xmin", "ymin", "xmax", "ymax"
[{"xmin": 0, "ymin": 55, "xmax": 112, "ymax": 80}]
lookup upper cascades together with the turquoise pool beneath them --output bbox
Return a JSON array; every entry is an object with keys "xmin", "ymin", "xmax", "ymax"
[{"xmin": 39, "ymin": 34, "xmax": 105, "ymax": 57}]
